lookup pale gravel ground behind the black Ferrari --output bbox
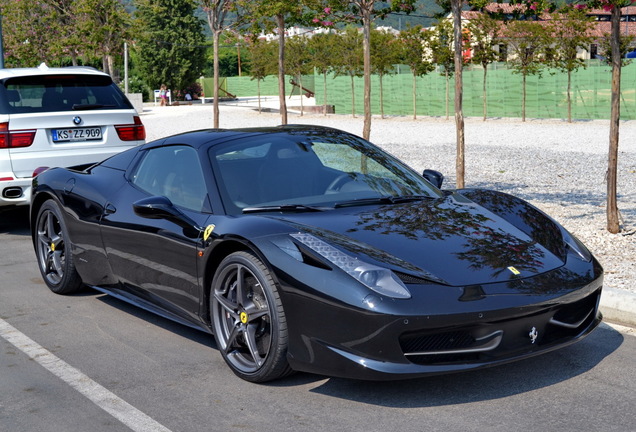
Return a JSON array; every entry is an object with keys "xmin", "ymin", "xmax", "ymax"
[{"xmin": 142, "ymin": 98, "xmax": 636, "ymax": 293}]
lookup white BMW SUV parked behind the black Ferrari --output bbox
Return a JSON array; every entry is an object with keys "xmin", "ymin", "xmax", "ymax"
[{"xmin": 0, "ymin": 64, "xmax": 146, "ymax": 208}]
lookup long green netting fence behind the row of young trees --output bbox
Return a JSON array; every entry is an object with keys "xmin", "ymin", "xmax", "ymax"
[{"xmin": 204, "ymin": 60, "xmax": 636, "ymax": 120}]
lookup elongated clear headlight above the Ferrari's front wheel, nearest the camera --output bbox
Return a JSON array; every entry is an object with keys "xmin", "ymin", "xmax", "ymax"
[{"xmin": 291, "ymin": 233, "xmax": 411, "ymax": 299}]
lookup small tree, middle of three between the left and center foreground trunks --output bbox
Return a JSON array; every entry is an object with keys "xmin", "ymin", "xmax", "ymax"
[{"xmin": 398, "ymin": 26, "xmax": 435, "ymax": 119}]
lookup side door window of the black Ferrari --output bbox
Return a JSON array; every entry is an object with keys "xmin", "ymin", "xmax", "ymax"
[{"xmin": 131, "ymin": 145, "xmax": 207, "ymax": 212}]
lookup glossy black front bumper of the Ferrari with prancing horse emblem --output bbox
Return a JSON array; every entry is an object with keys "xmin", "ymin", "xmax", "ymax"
[{"xmin": 286, "ymin": 276, "xmax": 603, "ymax": 380}]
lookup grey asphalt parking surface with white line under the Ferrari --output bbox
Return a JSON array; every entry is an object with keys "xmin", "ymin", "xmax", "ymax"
[{"xmin": 0, "ymin": 207, "xmax": 636, "ymax": 432}]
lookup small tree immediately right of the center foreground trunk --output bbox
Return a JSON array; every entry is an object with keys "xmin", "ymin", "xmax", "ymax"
[{"xmin": 466, "ymin": 13, "xmax": 501, "ymax": 121}]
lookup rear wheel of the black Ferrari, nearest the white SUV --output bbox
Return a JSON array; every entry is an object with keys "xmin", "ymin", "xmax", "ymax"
[{"xmin": 35, "ymin": 200, "xmax": 82, "ymax": 294}]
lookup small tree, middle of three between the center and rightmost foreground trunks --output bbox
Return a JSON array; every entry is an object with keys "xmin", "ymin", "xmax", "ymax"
[{"xmin": 503, "ymin": 21, "xmax": 549, "ymax": 122}]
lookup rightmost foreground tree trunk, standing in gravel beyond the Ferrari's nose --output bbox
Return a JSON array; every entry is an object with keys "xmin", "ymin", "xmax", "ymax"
[{"xmin": 607, "ymin": 6, "xmax": 622, "ymax": 234}]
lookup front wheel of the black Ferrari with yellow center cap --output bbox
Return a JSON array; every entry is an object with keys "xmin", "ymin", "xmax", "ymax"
[{"xmin": 210, "ymin": 252, "xmax": 292, "ymax": 383}]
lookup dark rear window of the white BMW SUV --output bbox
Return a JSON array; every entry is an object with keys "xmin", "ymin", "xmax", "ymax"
[{"xmin": 0, "ymin": 74, "xmax": 132, "ymax": 114}]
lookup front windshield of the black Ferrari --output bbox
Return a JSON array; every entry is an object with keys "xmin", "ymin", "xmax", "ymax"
[{"xmin": 210, "ymin": 131, "xmax": 441, "ymax": 214}]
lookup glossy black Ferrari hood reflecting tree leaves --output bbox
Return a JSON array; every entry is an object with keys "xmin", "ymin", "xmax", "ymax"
[{"xmin": 260, "ymin": 193, "xmax": 564, "ymax": 286}]
